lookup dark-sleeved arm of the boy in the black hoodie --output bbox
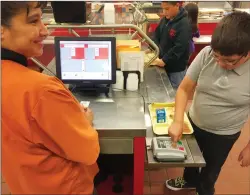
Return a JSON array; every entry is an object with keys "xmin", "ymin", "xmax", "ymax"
[{"xmin": 162, "ymin": 25, "xmax": 191, "ymax": 66}]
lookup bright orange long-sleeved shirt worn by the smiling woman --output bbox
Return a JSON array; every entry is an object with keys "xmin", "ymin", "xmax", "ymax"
[{"xmin": 1, "ymin": 60, "xmax": 100, "ymax": 194}]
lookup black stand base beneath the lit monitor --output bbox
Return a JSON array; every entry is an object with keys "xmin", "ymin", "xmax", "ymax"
[{"xmin": 70, "ymin": 84, "xmax": 110, "ymax": 96}]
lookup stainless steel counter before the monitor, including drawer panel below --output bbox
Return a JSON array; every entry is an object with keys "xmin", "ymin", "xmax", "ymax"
[{"xmin": 74, "ymin": 92, "xmax": 146, "ymax": 154}]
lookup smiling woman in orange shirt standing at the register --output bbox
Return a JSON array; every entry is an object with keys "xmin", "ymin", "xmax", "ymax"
[{"xmin": 1, "ymin": 1, "xmax": 100, "ymax": 194}]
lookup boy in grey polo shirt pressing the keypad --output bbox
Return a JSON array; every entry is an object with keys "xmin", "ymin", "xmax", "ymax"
[{"xmin": 166, "ymin": 12, "xmax": 250, "ymax": 195}]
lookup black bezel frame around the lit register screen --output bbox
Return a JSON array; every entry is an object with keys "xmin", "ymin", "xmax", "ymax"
[{"xmin": 55, "ymin": 37, "xmax": 117, "ymax": 84}]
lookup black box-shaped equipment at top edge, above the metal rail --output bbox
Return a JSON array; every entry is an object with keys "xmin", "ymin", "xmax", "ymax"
[{"xmin": 51, "ymin": 1, "xmax": 86, "ymax": 24}]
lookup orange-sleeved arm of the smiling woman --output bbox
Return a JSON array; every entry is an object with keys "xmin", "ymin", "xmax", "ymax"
[{"xmin": 31, "ymin": 78, "xmax": 100, "ymax": 165}]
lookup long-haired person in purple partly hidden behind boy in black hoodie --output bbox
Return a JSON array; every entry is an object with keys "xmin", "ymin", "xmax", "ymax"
[{"xmin": 184, "ymin": 3, "xmax": 200, "ymax": 56}]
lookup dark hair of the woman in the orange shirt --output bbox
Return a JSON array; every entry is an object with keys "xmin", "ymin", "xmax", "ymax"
[{"xmin": 1, "ymin": 1, "xmax": 47, "ymax": 26}]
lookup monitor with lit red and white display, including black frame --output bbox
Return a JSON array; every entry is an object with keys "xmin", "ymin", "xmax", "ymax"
[{"xmin": 55, "ymin": 37, "xmax": 116, "ymax": 84}]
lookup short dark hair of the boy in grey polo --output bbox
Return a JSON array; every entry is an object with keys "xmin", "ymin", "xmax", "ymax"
[{"xmin": 211, "ymin": 11, "xmax": 250, "ymax": 56}]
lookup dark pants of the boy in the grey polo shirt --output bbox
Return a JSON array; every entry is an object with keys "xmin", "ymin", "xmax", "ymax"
[{"xmin": 184, "ymin": 118, "xmax": 240, "ymax": 195}]
